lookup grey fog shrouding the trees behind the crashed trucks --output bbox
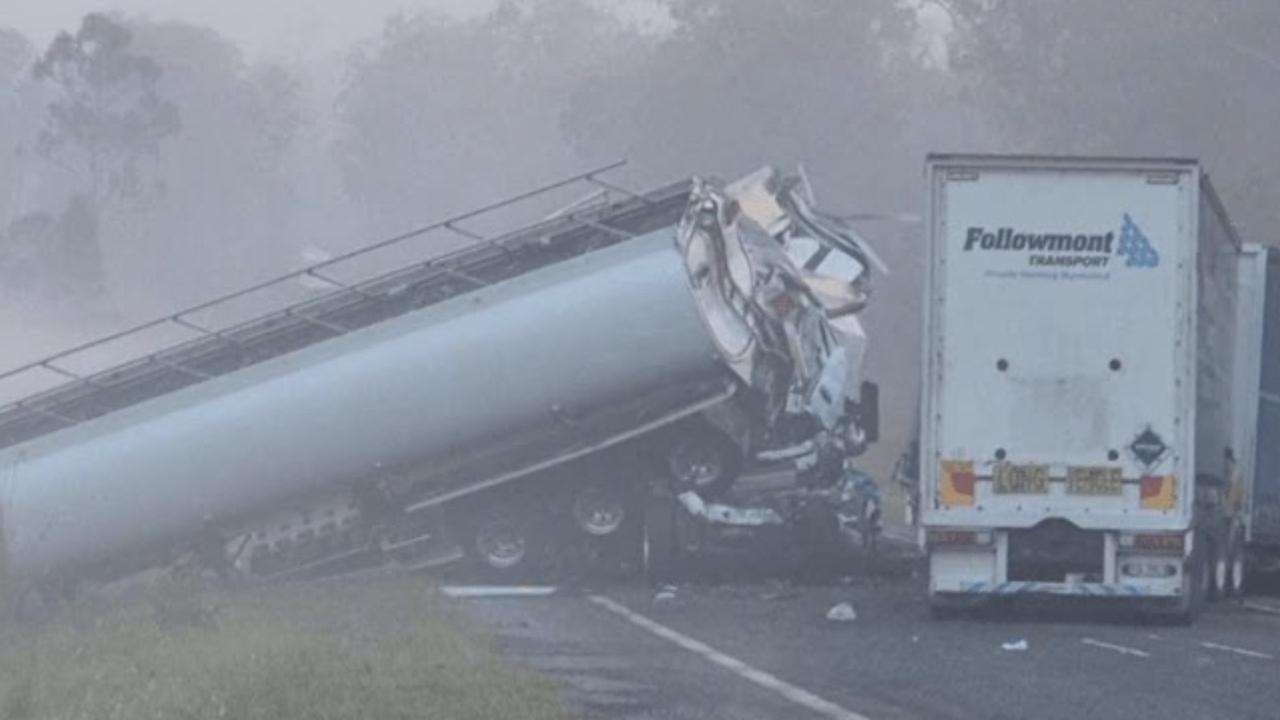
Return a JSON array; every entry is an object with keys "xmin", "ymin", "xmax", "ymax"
[{"xmin": 0, "ymin": 0, "xmax": 1280, "ymax": 476}]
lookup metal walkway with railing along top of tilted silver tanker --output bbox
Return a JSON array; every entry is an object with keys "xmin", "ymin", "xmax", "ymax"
[{"xmin": 0, "ymin": 161, "xmax": 689, "ymax": 448}]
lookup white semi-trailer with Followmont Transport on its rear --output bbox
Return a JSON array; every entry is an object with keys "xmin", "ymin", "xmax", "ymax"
[{"xmin": 919, "ymin": 155, "xmax": 1242, "ymax": 619}]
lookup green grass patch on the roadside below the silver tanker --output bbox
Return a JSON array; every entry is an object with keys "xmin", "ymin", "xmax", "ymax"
[{"xmin": 0, "ymin": 578, "xmax": 570, "ymax": 720}]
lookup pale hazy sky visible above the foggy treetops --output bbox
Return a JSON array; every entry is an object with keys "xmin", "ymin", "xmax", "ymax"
[{"xmin": 0, "ymin": 0, "xmax": 662, "ymax": 59}]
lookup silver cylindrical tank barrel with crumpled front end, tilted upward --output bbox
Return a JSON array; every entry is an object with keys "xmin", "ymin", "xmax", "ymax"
[{"xmin": 0, "ymin": 165, "xmax": 829, "ymax": 597}]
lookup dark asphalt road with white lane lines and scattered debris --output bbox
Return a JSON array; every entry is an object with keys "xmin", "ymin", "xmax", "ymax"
[{"xmin": 457, "ymin": 578, "xmax": 1280, "ymax": 720}]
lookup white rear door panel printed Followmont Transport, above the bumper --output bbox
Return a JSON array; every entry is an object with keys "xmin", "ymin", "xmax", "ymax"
[{"xmin": 922, "ymin": 158, "xmax": 1199, "ymax": 529}]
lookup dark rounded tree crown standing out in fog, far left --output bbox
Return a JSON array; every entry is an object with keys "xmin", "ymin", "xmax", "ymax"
[{"xmin": 33, "ymin": 13, "xmax": 180, "ymax": 202}]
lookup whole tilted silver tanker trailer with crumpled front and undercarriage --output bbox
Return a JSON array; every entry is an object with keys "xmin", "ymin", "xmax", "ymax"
[{"xmin": 0, "ymin": 162, "xmax": 875, "ymax": 594}]
